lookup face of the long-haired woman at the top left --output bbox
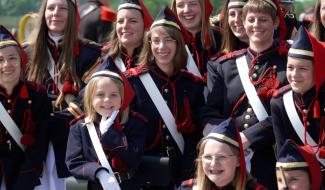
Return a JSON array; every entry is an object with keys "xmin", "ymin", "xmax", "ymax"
[{"xmin": 45, "ymin": 0, "xmax": 68, "ymax": 36}]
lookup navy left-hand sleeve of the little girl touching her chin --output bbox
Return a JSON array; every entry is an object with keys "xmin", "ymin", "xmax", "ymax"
[{"xmin": 66, "ymin": 122, "xmax": 104, "ymax": 181}]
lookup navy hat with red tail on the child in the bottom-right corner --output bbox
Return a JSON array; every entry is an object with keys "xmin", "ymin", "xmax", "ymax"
[{"xmin": 276, "ymin": 140, "xmax": 322, "ymax": 190}]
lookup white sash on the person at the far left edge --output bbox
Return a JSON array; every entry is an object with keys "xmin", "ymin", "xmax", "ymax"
[{"xmin": 0, "ymin": 102, "xmax": 25, "ymax": 151}]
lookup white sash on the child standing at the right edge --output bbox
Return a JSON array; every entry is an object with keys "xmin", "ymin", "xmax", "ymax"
[{"xmin": 283, "ymin": 90, "xmax": 325, "ymax": 166}]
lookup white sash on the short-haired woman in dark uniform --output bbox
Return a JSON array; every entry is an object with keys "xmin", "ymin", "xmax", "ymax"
[{"xmin": 236, "ymin": 55, "xmax": 268, "ymax": 121}]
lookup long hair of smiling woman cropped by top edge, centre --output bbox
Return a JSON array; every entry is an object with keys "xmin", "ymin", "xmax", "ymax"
[{"xmin": 171, "ymin": 0, "xmax": 216, "ymax": 50}]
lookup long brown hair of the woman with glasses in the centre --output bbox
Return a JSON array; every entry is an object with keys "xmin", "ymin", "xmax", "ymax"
[{"xmin": 139, "ymin": 26, "xmax": 187, "ymax": 71}]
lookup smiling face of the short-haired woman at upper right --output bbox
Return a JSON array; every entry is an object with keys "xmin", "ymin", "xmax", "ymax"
[{"xmin": 244, "ymin": 12, "xmax": 277, "ymax": 46}]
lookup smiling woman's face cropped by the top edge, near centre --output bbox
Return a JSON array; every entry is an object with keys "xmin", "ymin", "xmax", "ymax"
[{"xmin": 176, "ymin": 0, "xmax": 202, "ymax": 34}]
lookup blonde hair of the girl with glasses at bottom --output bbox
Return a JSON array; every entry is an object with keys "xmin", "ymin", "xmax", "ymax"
[{"xmin": 195, "ymin": 138, "xmax": 252, "ymax": 190}]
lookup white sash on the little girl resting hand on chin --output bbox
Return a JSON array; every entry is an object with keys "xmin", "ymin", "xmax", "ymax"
[{"xmin": 85, "ymin": 118, "xmax": 120, "ymax": 187}]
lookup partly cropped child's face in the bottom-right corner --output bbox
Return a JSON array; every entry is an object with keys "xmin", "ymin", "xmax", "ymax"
[{"xmin": 276, "ymin": 170, "xmax": 311, "ymax": 190}]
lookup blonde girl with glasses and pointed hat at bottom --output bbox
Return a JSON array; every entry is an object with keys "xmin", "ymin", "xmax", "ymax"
[{"xmin": 179, "ymin": 118, "xmax": 265, "ymax": 190}]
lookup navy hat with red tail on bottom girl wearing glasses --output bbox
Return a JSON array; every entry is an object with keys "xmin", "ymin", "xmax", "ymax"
[{"xmin": 205, "ymin": 118, "xmax": 246, "ymax": 189}]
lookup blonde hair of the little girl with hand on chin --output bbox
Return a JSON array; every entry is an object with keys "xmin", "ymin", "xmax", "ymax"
[{"xmin": 83, "ymin": 76, "xmax": 129, "ymax": 124}]
